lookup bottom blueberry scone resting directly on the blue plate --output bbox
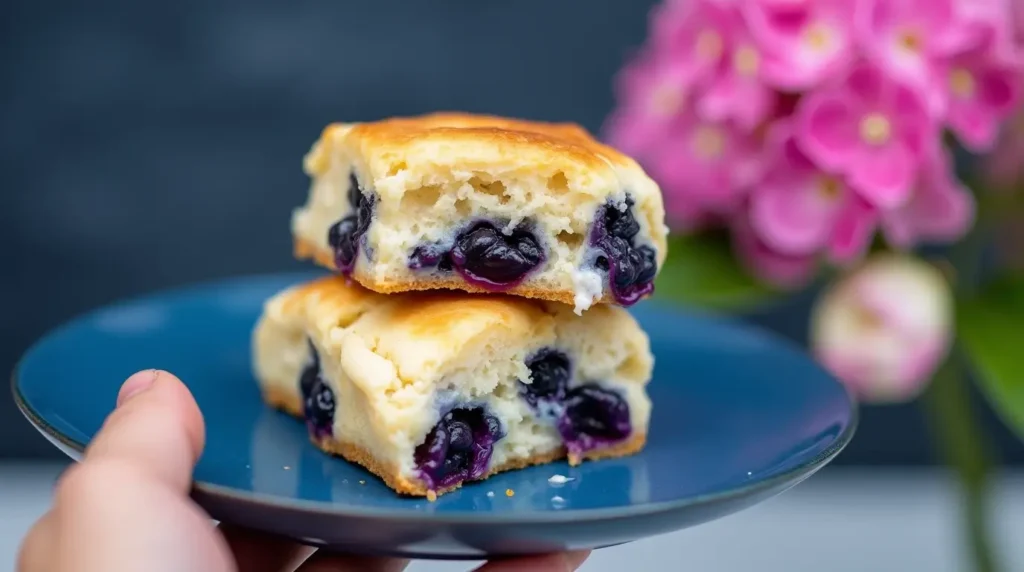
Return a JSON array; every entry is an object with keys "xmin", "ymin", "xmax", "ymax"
[{"xmin": 253, "ymin": 276, "xmax": 653, "ymax": 499}]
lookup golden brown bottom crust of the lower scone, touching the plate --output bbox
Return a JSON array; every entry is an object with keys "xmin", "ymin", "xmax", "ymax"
[{"xmin": 263, "ymin": 387, "xmax": 647, "ymax": 500}]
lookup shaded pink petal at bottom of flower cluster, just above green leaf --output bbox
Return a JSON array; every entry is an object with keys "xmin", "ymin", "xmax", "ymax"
[{"xmin": 731, "ymin": 216, "xmax": 817, "ymax": 290}]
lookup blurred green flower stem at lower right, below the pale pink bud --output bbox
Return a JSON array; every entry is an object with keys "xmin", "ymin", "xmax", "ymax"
[{"xmin": 925, "ymin": 355, "xmax": 999, "ymax": 572}]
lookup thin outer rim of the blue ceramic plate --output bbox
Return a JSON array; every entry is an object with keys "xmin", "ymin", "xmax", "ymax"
[{"xmin": 10, "ymin": 272, "xmax": 860, "ymax": 525}]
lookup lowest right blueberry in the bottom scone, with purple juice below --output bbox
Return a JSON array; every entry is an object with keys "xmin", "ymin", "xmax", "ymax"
[{"xmin": 558, "ymin": 384, "xmax": 631, "ymax": 450}]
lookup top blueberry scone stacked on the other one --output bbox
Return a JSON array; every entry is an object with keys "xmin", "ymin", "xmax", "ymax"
[{"xmin": 292, "ymin": 114, "xmax": 668, "ymax": 313}]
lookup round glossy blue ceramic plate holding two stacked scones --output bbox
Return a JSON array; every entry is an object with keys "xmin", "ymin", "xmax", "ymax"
[{"xmin": 13, "ymin": 274, "xmax": 856, "ymax": 559}]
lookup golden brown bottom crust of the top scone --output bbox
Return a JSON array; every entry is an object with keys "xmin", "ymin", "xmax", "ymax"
[{"xmin": 295, "ymin": 237, "xmax": 614, "ymax": 306}]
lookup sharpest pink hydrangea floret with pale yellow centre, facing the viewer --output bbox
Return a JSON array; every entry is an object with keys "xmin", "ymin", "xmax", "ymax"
[{"xmin": 796, "ymin": 65, "xmax": 939, "ymax": 209}]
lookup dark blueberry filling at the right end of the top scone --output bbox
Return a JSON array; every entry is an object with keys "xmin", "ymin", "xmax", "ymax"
[{"xmin": 590, "ymin": 196, "xmax": 657, "ymax": 306}]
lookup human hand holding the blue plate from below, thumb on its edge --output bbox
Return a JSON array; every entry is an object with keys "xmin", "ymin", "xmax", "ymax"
[{"xmin": 17, "ymin": 370, "xmax": 589, "ymax": 572}]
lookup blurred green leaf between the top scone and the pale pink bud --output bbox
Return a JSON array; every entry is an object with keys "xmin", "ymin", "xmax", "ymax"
[{"xmin": 654, "ymin": 233, "xmax": 780, "ymax": 311}]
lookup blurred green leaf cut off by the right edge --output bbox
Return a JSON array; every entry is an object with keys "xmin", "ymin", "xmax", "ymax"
[{"xmin": 956, "ymin": 276, "xmax": 1024, "ymax": 439}]
